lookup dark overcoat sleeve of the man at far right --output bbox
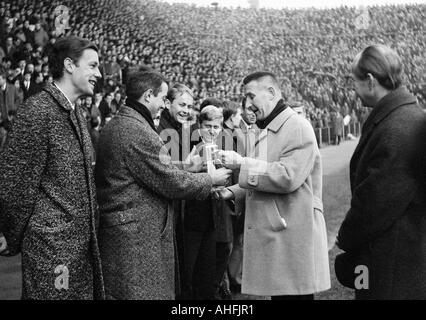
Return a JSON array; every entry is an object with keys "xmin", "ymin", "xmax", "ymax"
[{"xmin": 337, "ymin": 120, "xmax": 425, "ymax": 251}]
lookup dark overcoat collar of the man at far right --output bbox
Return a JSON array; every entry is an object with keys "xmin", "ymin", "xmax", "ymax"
[{"xmin": 364, "ymin": 86, "xmax": 417, "ymax": 131}]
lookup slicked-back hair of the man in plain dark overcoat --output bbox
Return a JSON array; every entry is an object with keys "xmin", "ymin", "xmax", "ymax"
[{"xmin": 352, "ymin": 45, "xmax": 402, "ymax": 90}]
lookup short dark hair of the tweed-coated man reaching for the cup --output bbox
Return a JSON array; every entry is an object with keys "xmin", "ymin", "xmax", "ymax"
[{"xmin": 126, "ymin": 71, "xmax": 167, "ymax": 100}]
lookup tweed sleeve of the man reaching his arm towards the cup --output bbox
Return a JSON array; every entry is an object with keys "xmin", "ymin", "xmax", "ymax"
[{"xmin": 125, "ymin": 124, "xmax": 212, "ymax": 200}]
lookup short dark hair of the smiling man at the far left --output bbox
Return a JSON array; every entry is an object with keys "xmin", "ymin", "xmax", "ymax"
[{"xmin": 49, "ymin": 36, "xmax": 98, "ymax": 80}]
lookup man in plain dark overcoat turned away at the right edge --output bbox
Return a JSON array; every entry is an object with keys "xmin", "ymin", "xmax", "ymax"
[{"xmin": 336, "ymin": 45, "xmax": 426, "ymax": 300}]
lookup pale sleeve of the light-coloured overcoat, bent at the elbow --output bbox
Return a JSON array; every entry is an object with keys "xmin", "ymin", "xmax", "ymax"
[{"xmin": 239, "ymin": 121, "xmax": 316, "ymax": 194}]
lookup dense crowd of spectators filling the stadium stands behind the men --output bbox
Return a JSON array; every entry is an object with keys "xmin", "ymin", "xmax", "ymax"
[{"xmin": 0, "ymin": 0, "xmax": 426, "ymax": 128}]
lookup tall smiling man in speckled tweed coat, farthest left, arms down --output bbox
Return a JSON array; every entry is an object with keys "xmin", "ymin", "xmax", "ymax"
[{"xmin": 0, "ymin": 37, "xmax": 104, "ymax": 299}]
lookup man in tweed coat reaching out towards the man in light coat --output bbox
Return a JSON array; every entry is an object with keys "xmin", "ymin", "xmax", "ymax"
[{"xmin": 96, "ymin": 71, "xmax": 232, "ymax": 300}]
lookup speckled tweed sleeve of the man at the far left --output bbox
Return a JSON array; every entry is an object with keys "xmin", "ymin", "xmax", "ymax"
[{"xmin": 0, "ymin": 100, "xmax": 49, "ymax": 255}]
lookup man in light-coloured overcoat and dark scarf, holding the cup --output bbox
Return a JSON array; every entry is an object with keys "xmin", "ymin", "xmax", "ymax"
[{"xmin": 219, "ymin": 72, "xmax": 330, "ymax": 300}]
